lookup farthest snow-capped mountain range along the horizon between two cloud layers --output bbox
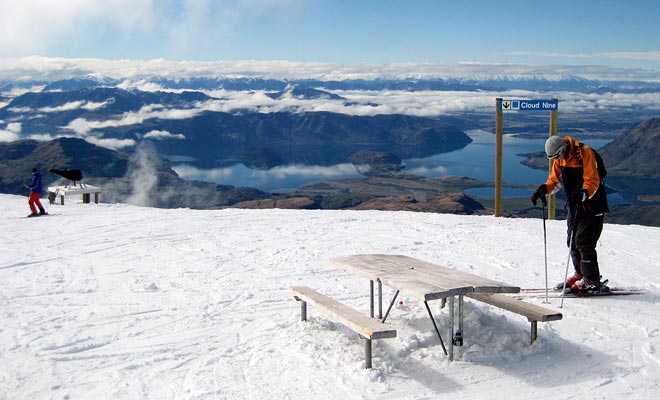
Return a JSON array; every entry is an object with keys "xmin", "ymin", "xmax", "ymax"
[{"xmin": 7, "ymin": 73, "xmax": 660, "ymax": 93}]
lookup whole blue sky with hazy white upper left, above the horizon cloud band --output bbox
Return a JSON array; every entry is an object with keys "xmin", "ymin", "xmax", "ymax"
[{"xmin": 0, "ymin": 0, "xmax": 660, "ymax": 70}]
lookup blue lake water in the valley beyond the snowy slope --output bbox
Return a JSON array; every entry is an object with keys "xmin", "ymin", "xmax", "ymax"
[{"xmin": 174, "ymin": 130, "xmax": 610, "ymax": 198}]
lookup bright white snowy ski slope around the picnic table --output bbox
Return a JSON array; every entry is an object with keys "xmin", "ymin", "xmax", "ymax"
[{"xmin": 0, "ymin": 195, "xmax": 660, "ymax": 399}]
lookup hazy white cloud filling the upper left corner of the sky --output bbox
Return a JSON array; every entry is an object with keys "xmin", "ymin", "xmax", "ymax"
[{"xmin": 0, "ymin": 0, "xmax": 300, "ymax": 57}]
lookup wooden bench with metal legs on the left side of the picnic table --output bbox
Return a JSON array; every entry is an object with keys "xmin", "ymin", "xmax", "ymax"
[{"xmin": 289, "ymin": 286, "xmax": 396, "ymax": 368}]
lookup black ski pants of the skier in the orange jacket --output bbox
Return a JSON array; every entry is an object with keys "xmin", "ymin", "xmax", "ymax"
[{"xmin": 566, "ymin": 213, "xmax": 603, "ymax": 282}]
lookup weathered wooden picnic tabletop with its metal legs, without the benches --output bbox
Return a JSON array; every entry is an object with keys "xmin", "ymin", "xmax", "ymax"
[{"xmin": 329, "ymin": 254, "xmax": 520, "ymax": 360}]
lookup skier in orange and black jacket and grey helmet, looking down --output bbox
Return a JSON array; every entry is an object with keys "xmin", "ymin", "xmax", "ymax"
[{"xmin": 532, "ymin": 136, "xmax": 609, "ymax": 293}]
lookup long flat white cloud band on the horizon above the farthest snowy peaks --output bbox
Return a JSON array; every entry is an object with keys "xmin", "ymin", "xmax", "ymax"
[{"xmin": 0, "ymin": 56, "xmax": 660, "ymax": 83}]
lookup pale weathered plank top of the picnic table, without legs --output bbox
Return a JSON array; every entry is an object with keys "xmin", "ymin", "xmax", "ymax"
[{"xmin": 329, "ymin": 254, "xmax": 520, "ymax": 301}]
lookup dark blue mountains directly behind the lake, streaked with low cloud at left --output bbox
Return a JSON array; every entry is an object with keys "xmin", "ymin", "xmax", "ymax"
[{"xmin": 0, "ymin": 87, "xmax": 471, "ymax": 168}]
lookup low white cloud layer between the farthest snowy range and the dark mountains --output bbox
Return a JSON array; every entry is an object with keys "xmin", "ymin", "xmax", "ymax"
[{"xmin": 54, "ymin": 90, "xmax": 660, "ymax": 139}]
